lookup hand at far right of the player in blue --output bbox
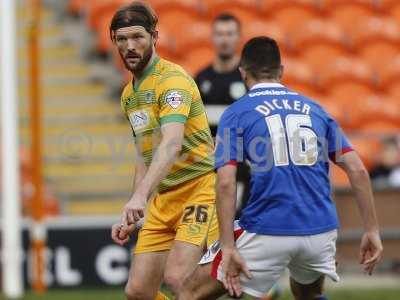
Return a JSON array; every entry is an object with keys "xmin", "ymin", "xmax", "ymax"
[{"xmin": 360, "ymin": 230, "xmax": 383, "ymax": 275}]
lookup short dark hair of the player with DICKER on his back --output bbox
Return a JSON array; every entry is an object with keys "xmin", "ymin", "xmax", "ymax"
[{"xmin": 240, "ymin": 36, "xmax": 281, "ymax": 80}]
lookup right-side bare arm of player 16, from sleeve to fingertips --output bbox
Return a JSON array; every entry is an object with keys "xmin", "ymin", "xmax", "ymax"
[{"xmin": 338, "ymin": 151, "xmax": 383, "ymax": 275}]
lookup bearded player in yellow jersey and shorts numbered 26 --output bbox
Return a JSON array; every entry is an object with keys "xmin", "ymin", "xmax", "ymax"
[{"xmin": 110, "ymin": 1, "xmax": 218, "ymax": 300}]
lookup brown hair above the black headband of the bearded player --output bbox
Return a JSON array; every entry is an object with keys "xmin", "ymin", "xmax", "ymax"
[{"xmin": 110, "ymin": 1, "xmax": 158, "ymax": 40}]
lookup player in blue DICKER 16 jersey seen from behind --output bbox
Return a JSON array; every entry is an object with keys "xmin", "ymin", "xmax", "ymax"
[{"xmin": 178, "ymin": 37, "xmax": 383, "ymax": 300}]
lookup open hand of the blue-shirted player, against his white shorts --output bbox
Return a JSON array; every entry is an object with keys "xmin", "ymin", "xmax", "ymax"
[{"xmin": 222, "ymin": 248, "xmax": 251, "ymax": 297}]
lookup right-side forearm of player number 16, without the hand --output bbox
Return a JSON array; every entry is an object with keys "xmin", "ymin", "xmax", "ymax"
[{"xmin": 347, "ymin": 168, "xmax": 379, "ymax": 231}]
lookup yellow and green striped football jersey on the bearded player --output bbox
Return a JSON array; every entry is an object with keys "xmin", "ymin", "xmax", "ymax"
[{"xmin": 121, "ymin": 57, "xmax": 214, "ymax": 192}]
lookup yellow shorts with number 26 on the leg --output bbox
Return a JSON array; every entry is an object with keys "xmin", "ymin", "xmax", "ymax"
[{"xmin": 135, "ymin": 172, "xmax": 219, "ymax": 253}]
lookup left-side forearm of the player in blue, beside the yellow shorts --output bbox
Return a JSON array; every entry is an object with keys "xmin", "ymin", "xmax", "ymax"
[{"xmin": 216, "ymin": 176, "xmax": 236, "ymax": 248}]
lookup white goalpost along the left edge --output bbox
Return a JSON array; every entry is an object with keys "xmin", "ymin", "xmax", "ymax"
[{"xmin": 0, "ymin": 0, "xmax": 23, "ymax": 299}]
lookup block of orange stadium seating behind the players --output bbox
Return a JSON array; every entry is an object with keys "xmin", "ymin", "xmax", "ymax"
[{"xmin": 68, "ymin": 0, "xmax": 400, "ymax": 187}]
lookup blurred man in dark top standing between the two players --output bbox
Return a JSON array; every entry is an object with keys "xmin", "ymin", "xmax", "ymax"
[{"xmin": 195, "ymin": 13, "xmax": 250, "ymax": 216}]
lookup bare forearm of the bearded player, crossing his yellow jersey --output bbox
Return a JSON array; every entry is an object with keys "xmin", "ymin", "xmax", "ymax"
[{"xmin": 136, "ymin": 141, "xmax": 182, "ymax": 197}]
